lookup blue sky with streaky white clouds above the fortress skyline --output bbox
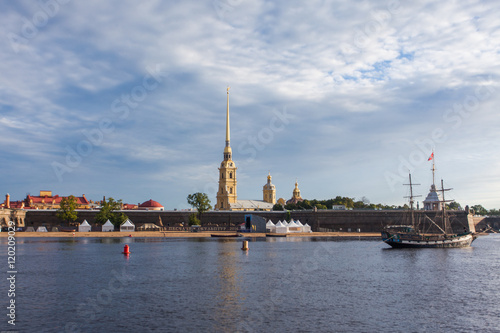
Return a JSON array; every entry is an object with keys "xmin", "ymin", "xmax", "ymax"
[{"xmin": 0, "ymin": 0, "xmax": 500, "ymax": 209}]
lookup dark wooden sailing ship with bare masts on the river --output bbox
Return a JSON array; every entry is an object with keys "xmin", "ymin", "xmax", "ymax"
[{"xmin": 382, "ymin": 152, "xmax": 476, "ymax": 248}]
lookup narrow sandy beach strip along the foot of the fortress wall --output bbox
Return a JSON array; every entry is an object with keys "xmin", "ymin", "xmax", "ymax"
[{"xmin": 0, "ymin": 231, "xmax": 380, "ymax": 239}]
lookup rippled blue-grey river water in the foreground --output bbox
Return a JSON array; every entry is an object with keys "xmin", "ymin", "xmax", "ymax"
[{"xmin": 0, "ymin": 235, "xmax": 500, "ymax": 332}]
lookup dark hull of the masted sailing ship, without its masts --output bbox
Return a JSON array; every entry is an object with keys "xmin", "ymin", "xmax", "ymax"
[{"xmin": 382, "ymin": 232, "xmax": 476, "ymax": 248}]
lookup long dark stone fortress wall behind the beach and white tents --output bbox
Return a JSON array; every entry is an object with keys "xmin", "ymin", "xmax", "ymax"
[{"xmin": 26, "ymin": 210, "xmax": 473, "ymax": 232}]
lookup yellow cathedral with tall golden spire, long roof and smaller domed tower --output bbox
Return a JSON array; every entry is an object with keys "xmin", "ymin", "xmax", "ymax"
[{"xmin": 214, "ymin": 87, "xmax": 276, "ymax": 211}]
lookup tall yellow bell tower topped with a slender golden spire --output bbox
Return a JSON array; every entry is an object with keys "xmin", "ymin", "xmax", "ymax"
[{"xmin": 214, "ymin": 87, "xmax": 238, "ymax": 210}]
